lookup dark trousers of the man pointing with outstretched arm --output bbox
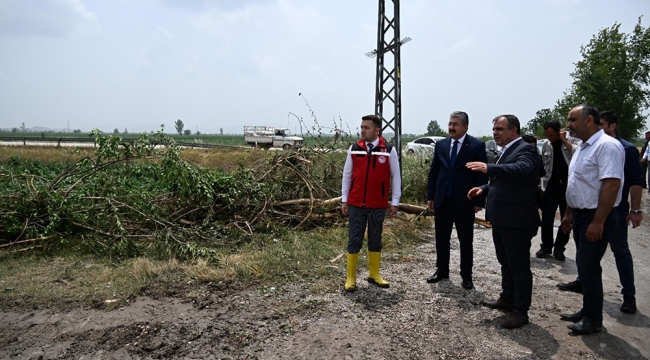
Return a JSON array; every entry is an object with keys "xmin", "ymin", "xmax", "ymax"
[{"xmin": 492, "ymin": 226, "xmax": 537, "ymax": 314}]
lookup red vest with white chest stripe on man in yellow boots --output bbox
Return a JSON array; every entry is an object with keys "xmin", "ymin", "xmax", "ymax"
[{"xmin": 348, "ymin": 136, "xmax": 393, "ymax": 209}]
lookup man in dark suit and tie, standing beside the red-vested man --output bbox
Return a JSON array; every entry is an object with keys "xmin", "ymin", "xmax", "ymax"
[{"xmin": 427, "ymin": 111, "xmax": 487, "ymax": 290}]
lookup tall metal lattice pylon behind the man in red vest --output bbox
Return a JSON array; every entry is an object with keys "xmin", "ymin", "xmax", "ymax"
[{"xmin": 366, "ymin": 0, "xmax": 411, "ymax": 169}]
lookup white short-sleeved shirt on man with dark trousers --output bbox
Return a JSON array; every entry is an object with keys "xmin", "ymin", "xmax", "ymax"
[{"xmin": 566, "ymin": 130, "xmax": 625, "ymax": 209}]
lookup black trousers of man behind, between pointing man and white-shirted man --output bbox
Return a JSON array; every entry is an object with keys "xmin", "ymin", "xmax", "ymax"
[{"xmin": 541, "ymin": 181, "xmax": 569, "ymax": 253}]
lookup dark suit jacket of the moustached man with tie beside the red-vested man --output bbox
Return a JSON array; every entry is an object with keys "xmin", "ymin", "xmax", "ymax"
[{"xmin": 427, "ymin": 135, "xmax": 488, "ymax": 207}]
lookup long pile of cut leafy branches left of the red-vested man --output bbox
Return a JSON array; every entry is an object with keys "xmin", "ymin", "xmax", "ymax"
[{"xmin": 0, "ymin": 129, "xmax": 354, "ymax": 258}]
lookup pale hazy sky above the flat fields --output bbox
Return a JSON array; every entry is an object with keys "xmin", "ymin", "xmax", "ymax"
[{"xmin": 0, "ymin": 0, "xmax": 650, "ymax": 136}]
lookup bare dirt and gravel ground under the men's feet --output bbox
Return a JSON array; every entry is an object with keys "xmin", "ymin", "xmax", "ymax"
[{"xmin": 0, "ymin": 193, "xmax": 650, "ymax": 359}]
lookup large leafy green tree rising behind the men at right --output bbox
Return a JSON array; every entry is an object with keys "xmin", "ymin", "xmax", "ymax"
[{"xmin": 556, "ymin": 17, "xmax": 650, "ymax": 139}]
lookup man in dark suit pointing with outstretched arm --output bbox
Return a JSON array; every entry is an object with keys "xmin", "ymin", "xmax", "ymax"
[{"xmin": 467, "ymin": 115, "xmax": 542, "ymax": 329}]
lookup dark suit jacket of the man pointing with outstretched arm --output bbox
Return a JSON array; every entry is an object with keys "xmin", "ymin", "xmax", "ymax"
[{"xmin": 481, "ymin": 140, "xmax": 542, "ymax": 228}]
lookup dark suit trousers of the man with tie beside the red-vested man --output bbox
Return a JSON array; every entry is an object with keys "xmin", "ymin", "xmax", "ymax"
[{"xmin": 435, "ymin": 196, "xmax": 475, "ymax": 278}]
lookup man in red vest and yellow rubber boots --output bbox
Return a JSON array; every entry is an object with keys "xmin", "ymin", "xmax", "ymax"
[{"xmin": 341, "ymin": 115, "xmax": 402, "ymax": 292}]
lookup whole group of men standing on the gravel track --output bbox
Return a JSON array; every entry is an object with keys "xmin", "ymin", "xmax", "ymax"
[{"xmin": 341, "ymin": 104, "xmax": 650, "ymax": 334}]
